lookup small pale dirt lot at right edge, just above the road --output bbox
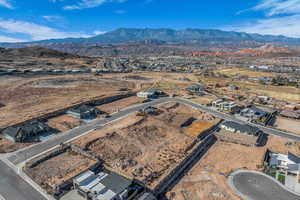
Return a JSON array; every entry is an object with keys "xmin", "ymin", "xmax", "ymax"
[{"xmin": 275, "ymin": 117, "xmax": 300, "ymax": 135}]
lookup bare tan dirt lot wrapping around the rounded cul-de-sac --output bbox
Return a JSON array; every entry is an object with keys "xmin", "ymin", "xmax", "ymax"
[{"xmin": 168, "ymin": 136, "xmax": 300, "ymax": 200}]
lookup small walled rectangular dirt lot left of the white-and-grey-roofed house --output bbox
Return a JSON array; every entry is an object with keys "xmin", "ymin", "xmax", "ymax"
[{"xmin": 25, "ymin": 150, "xmax": 96, "ymax": 193}]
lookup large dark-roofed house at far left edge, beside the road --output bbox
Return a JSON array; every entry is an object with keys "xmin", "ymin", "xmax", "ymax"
[{"xmin": 2, "ymin": 121, "xmax": 53, "ymax": 142}]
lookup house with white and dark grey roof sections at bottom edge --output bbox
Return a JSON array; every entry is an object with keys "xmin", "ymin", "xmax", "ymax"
[{"xmin": 73, "ymin": 170, "xmax": 132, "ymax": 200}]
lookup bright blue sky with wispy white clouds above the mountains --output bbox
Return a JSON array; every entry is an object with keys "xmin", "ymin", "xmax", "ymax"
[{"xmin": 0, "ymin": 0, "xmax": 300, "ymax": 42}]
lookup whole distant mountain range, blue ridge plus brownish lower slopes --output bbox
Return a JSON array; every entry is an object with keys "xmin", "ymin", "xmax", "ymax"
[{"xmin": 0, "ymin": 28, "xmax": 300, "ymax": 56}]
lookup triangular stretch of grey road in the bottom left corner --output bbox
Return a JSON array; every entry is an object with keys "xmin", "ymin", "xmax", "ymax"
[{"xmin": 0, "ymin": 161, "xmax": 46, "ymax": 200}]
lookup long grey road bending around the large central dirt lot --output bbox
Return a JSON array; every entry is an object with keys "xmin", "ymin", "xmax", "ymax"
[{"xmin": 8, "ymin": 98, "xmax": 300, "ymax": 164}]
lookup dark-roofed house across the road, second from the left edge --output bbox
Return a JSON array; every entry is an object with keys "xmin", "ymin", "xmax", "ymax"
[{"xmin": 67, "ymin": 105, "xmax": 103, "ymax": 119}]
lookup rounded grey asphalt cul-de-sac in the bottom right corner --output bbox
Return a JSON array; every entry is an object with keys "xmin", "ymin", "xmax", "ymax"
[{"xmin": 229, "ymin": 171, "xmax": 300, "ymax": 200}]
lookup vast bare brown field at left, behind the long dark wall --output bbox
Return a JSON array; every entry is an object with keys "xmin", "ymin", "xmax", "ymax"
[{"xmin": 0, "ymin": 75, "xmax": 135, "ymax": 127}]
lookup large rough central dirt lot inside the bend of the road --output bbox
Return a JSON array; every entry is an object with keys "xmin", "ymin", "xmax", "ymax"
[{"xmin": 74, "ymin": 103, "xmax": 218, "ymax": 188}]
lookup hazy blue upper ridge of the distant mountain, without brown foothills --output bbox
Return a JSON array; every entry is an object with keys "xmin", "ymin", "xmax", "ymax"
[{"xmin": 0, "ymin": 28, "xmax": 300, "ymax": 44}]
